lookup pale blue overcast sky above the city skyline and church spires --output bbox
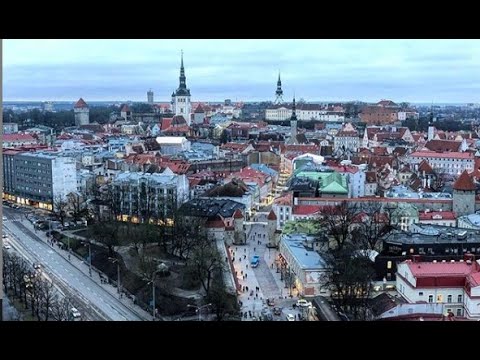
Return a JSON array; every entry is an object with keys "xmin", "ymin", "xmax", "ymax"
[{"xmin": 3, "ymin": 39, "xmax": 480, "ymax": 103}]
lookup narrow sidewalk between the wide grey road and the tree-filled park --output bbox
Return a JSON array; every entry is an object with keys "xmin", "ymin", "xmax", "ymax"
[{"xmin": 20, "ymin": 219, "xmax": 152, "ymax": 320}]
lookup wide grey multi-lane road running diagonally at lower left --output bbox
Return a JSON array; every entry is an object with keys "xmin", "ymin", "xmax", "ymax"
[{"xmin": 3, "ymin": 207, "xmax": 147, "ymax": 321}]
